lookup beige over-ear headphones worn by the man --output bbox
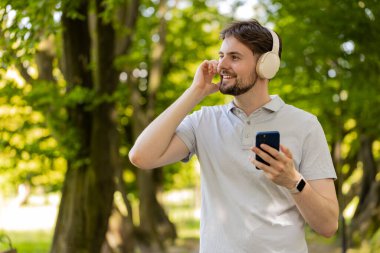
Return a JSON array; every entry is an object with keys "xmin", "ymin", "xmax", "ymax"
[{"xmin": 256, "ymin": 29, "xmax": 280, "ymax": 79}]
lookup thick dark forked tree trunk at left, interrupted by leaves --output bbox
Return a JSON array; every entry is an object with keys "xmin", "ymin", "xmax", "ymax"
[{"xmin": 51, "ymin": 1, "xmax": 119, "ymax": 253}]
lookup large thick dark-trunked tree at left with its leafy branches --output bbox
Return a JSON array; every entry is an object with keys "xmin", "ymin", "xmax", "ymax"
[{"xmin": 2, "ymin": 1, "xmax": 137, "ymax": 252}]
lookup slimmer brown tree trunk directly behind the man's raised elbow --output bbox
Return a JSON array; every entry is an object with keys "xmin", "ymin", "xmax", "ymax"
[{"xmin": 132, "ymin": 0, "xmax": 176, "ymax": 251}]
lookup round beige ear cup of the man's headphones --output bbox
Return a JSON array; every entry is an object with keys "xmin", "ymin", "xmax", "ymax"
[{"xmin": 256, "ymin": 51, "xmax": 280, "ymax": 79}]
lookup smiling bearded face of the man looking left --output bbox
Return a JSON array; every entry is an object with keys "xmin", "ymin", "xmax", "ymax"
[{"xmin": 218, "ymin": 36, "xmax": 257, "ymax": 96}]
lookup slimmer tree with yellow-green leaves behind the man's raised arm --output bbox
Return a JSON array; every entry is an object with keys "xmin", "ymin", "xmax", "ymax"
[{"xmin": 123, "ymin": 1, "xmax": 227, "ymax": 250}]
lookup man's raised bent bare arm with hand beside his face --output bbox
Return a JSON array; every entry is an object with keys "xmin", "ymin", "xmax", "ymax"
[{"xmin": 129, "ymin": 61, "xmax": 219, "ymax": 169}]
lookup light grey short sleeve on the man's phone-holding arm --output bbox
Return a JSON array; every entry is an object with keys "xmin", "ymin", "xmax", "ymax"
[{"xmin": 300, "ymin": 117, "xmax": 337, "ymax": 180}]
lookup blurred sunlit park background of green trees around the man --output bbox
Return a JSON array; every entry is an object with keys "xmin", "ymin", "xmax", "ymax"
[{"xmin": 0, "ymin": 0, "xmax": 380, "ymax": 253}]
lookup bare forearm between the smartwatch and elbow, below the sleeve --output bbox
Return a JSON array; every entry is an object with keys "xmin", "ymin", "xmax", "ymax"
[{"xmin": 293, "ymin": 180, "xmax": 339, "ymax": 237}]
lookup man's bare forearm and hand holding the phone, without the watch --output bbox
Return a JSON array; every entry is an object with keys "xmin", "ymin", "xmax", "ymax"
[{"xmin": 251, "ymin": 144, "xmax": 339, "ymax": 237}]
